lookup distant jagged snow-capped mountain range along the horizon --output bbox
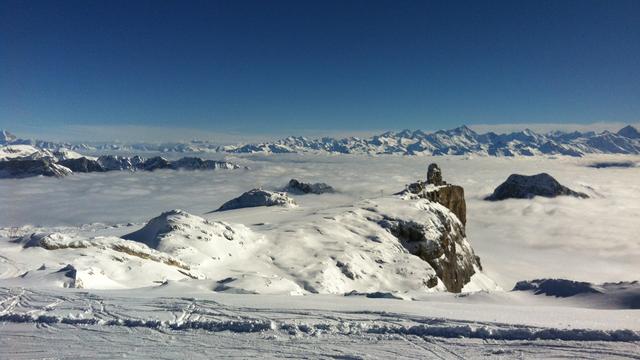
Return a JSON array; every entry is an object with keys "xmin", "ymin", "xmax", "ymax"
[{"xmin": 0, "ymin": 125, "xmax": 640, "ymax": 156}]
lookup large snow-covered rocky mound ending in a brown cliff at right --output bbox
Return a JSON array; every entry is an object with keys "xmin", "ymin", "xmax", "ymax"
[{"xmin": 0, "ymin": 196, "xmax": 496, "ymax": 297}]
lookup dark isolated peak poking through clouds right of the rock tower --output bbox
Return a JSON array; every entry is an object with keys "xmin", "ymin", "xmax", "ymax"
[{"xmin": 485, "ymin": 173, "xmax": 589, "ymax": 201}]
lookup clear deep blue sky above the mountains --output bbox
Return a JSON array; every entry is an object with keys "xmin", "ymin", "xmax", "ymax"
[{"xmin": 0, "ymin": 0, "xmax": 640, "ymax": 134}]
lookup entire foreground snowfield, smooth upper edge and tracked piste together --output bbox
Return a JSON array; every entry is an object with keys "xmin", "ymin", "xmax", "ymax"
[{"xmin": 0, "ymin": 284, "xmax": 640, "ymax": 359}]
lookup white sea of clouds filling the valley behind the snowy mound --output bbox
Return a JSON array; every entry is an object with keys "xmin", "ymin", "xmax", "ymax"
[{"xmin": 0, "ymin": 154, "xmax": 640, "ymax": 289}]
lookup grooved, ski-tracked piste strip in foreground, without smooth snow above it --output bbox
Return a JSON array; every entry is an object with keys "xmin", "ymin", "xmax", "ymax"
[{"xmin": 0, "ymin": 288, "xmax": 640, "ymax": 359}]
